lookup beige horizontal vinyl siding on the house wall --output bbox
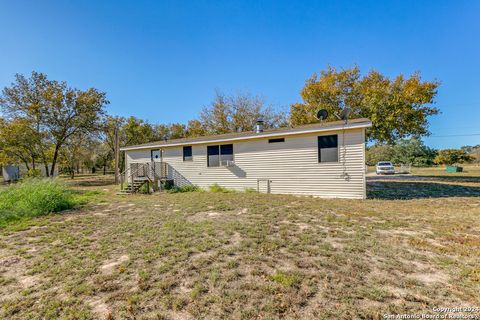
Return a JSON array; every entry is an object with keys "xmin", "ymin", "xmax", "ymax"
[{"xmin": 126, "ymin": 129, "xmax": 365, "ymax": 199}]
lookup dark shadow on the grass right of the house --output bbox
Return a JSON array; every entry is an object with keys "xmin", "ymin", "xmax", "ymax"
[{"xmin": 367, "ymin": 177, "xmax": 480, "ymax": 200}]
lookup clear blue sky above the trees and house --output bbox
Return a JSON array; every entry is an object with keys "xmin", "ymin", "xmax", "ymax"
[{"xmin": 0, "ymin": 0, "xmax": 480, "ymax": 148}]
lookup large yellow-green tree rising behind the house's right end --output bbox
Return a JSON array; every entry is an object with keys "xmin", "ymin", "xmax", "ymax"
[{"xmin": 290, "ymin": 67, "xmax": 440, "ymax": 143}]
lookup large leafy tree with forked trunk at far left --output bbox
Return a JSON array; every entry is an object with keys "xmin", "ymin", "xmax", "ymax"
[{"xmin": 0, "ymin": 72, "xmax": 109, "ymax": 175}]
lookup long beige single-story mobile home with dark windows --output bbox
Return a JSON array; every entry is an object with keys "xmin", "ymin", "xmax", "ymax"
[{"xmin": 121, "ymin": 118, "xmax": 372, "ymax": 199}]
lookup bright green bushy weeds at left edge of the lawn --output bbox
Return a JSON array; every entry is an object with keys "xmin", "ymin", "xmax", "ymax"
[{"xmin": 0, "ymin": 179, "xmax": 75, "ymax": 226}]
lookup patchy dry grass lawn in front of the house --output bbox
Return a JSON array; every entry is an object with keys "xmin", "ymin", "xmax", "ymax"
[{"xmin": 0, "ymin": 170, "xmax": 480, "ymax": 319}]
